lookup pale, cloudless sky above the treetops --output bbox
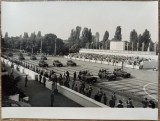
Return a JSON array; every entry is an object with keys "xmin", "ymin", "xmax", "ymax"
[{"xmin": 1, "ymin": 1, "xmax": 158, "ymax": 42}]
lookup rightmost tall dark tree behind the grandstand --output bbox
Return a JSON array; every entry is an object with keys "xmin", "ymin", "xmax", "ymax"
[{"xmin": 143, "ymin": 29, "xmax": 151, "ymax": 51}]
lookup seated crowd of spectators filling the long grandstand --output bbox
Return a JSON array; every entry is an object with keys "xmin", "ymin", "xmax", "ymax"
[{"xmin": 68, "ymin": 53, "xmax": 151, "ymax": 65}]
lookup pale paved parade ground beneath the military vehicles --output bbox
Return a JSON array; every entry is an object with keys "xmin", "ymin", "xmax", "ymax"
[{"xmin": 11, "ymin": 55, "xmax": 158, "ymax": 106}]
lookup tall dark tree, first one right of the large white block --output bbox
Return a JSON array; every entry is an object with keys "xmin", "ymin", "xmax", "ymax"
[{"xmin": 130, "ymin": 29, "xmax": 138, "ymax": 50}]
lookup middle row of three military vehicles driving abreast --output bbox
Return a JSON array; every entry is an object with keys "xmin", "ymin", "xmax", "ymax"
[{"xmin": 39, "ymin": 60, "xmax": 77, "ymax": 67}]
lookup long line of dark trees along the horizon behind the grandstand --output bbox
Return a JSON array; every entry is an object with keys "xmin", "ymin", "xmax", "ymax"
[{"xmin": 1, "ymin": 26, "xmax": 154, "ymax": 55}]
